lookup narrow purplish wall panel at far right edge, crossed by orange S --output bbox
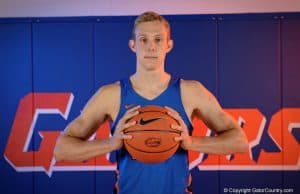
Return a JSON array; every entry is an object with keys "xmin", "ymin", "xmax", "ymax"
[{"xmin": 282, "ymin": 18, "xmax": 300, "ymax": 193}]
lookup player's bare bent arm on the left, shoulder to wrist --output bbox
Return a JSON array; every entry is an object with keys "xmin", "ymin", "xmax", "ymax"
[{"xmin": 54, "ymin": 84, "xmax": 135, "ymax": 161}]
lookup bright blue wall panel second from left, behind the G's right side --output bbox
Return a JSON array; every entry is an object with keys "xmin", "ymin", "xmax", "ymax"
[{"xmin": 33, "ymin": 20, "xmax": 95, "ymax": 194}]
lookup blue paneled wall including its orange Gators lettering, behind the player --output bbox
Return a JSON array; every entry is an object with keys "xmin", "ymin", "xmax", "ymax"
[{"xmin": 0, "ymin": 13, "xmax": 300, "ymax": 194}]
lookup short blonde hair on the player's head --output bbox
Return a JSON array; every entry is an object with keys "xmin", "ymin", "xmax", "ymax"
[{"xmin": 131, "ymin": 11, "xmax": 171, "ymax": 40}]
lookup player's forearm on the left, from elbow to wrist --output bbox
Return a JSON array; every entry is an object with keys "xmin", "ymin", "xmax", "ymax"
[{"xmin": 54, "ymin": 136, "xmax": 115, "ymax": 162}]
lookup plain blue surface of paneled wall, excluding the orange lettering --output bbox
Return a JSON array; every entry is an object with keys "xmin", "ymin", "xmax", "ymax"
[{"xmin": 0, "ymin": 13, "xmax": 300, "ymax": 194}]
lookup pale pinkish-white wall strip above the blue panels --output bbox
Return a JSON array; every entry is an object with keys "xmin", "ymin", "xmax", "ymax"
[{"xmin": 0, "ymin": 0, "xmax": 300, "ymax": 17}]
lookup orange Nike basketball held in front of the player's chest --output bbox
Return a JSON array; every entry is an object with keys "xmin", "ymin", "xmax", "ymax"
[{"xmin": 124, "ymin": 105, "xmax": 180, "ymax": 163}]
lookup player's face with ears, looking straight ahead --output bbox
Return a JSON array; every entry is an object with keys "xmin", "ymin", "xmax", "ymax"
[{"xmin": 129, "ymin": 21, "xmax": 173, "ymax": 70}]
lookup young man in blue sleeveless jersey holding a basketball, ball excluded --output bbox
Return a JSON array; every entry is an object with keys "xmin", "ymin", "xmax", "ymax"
[{"xmin": 55, "ymin": 12, "xmax": 248, "ymax": 194}]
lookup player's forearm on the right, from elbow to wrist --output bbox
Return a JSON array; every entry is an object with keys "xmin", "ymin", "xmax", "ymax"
[{"xmin": 187, "ymin": 129, "xmax": 248, "ymax": 154}]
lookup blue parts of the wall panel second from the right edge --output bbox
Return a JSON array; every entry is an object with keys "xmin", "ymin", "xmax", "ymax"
[{"xmin": 218, "ymin": 17, "xmax": 282, "ymax": 193}]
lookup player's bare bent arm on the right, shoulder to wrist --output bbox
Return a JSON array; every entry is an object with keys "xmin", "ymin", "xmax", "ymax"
[{"xmin": 174, "ymin": 81, "xmax": 248, "ymax": 154}]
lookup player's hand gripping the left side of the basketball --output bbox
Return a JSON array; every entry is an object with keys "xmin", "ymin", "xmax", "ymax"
[{"xmin": 110, "ymin": 106, "xmax": 141, "ymax": 150}]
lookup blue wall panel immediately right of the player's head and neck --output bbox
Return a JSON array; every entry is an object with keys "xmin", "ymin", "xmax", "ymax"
[{"xmin": 166, "ymin": 18, "xmax": 219, "ymax": 194}]
